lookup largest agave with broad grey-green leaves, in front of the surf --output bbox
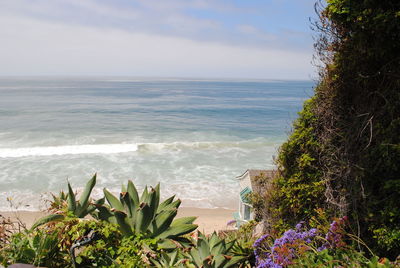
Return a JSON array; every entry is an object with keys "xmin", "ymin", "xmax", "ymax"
[{"xmin": 92, "ymin": 181, "xmax": 197, "ymax": 240}]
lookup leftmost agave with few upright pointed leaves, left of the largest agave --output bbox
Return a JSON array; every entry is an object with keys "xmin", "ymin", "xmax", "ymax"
[{"xmin": 32, "ymin": 174, "xmax": 99, "ymax": 229}]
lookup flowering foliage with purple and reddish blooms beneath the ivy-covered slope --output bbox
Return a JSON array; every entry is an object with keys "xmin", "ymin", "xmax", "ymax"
[{"xmin": 253, "ymin": 217, "xmax": 399, "ymax": 268}]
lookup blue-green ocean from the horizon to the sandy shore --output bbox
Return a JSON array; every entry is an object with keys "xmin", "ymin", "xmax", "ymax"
[{"xmin": 0, "ymin": 77, "xmax": 315, "ymax": 211}]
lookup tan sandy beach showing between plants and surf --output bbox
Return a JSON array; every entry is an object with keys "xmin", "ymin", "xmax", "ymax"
[{"xmin": 0, "ymin": 207, "xmax": 235, "ymax": 234}]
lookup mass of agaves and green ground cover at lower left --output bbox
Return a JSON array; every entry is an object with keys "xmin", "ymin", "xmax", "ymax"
[{"xmin": 0, "ymin": 175, "xmax": 248, "ymax": 268}]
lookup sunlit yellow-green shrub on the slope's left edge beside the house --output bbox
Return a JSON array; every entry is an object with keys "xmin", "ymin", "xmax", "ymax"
[{"xmin": 258, "ymin": 98, "xmax": 329, "ymax": 233}]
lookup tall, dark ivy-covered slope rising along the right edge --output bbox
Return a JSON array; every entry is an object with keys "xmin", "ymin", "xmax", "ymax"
[{"xmin": 265, "ymin": 0, "xmax": 400, "ymax": 256}]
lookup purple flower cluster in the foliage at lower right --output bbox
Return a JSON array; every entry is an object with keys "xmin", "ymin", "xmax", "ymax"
[{"xmin": 253, "ymin": 222, "xmax": 318, "ymax": 268}]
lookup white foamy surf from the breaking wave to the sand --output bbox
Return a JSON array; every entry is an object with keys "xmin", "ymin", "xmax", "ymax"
[{"xmin": 0, "ymin": 139, "xmax": 276, "ymax": 211}]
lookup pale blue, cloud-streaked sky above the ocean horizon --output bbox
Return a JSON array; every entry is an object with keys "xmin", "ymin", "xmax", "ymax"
[{"xmin": 0, "ymin": 0, "xmax": 316, "ymax": 80}]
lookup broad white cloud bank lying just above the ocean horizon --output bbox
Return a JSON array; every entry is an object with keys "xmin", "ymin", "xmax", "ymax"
[{"xmin": 0, "ymin": 16, "xmax": 311, "ymax": 79}]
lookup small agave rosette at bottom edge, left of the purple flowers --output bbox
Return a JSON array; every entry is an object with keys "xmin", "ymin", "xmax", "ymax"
[{"xmin": 187, "ymin": 232, "xmax": 246, "ymax": 268}]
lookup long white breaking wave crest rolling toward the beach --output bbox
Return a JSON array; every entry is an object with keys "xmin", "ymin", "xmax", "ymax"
[{"xmin": 0, "ymin": 139, "xmax": 269, "ymax": 158}]
